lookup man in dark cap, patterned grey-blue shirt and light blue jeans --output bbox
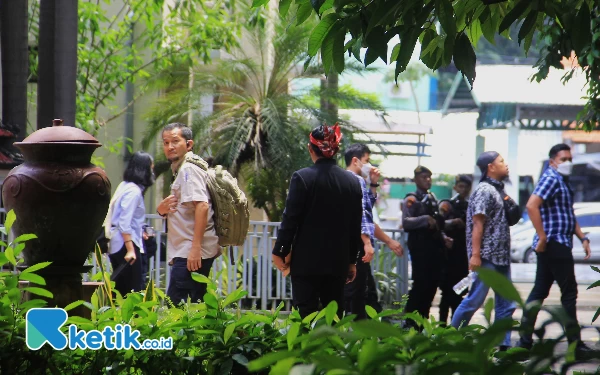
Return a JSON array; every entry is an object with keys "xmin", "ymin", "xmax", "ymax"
[{"xmin": 452, "ymin": 151, "xmax": 516, "ymax": 350}]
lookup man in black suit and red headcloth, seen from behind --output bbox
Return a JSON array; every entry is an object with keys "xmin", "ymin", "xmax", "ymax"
[{"xmin": 273, "ymin": 124, "xmax": 362, "ymax": 318}]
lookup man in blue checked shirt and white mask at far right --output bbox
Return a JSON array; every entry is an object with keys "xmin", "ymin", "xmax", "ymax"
[{"xmin": 518, "ymin": 144, "xmax": 591, "ymax": 359}]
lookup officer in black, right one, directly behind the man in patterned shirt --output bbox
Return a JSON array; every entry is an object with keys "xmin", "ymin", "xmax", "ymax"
[{"xmin": 440, "ymin": 175, "xmax": 473, "ymax": 323}]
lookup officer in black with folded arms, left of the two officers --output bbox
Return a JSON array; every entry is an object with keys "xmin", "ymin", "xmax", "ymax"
[{"xmin": 402, "ymin": 166, "xmax": 452, "ymax": 326}]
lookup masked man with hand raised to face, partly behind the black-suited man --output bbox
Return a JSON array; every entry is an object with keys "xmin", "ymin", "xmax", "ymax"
[{"xmin": 344, "ymin": 143, "xmax": 403, "ymax": 319}]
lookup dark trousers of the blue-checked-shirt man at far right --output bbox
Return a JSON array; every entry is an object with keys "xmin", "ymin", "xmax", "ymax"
[{"xmin": 521, "ymin": 241, "xmax": 580, "ymax": 345}]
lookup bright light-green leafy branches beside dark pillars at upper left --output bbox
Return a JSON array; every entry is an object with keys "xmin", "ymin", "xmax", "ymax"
[{"xmin": 29, "ymin": 0, "xmax": 239, "ymax": 134}]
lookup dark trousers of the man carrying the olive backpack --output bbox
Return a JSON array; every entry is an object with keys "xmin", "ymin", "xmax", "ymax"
[{"xmin": 167, "ymin": 258, "xmax": 215, "ymax": 305}]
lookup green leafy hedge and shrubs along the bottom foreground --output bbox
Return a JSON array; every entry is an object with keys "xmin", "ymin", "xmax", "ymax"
[{"xmin": 0, "ymin": 213, "xmax": 600, "ymax": 375}]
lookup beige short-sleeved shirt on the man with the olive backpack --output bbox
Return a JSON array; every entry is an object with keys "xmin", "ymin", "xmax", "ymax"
[{"xmin": 167, "ymin": 155, "xmax": 221, "ymax": 262}]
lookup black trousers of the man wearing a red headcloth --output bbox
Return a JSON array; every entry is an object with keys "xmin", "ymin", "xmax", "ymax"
[{"xmin": 292, "ymin": 272, "xmax": 347, "ymax": 318}]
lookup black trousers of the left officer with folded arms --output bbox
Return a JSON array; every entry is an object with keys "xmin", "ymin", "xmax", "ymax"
[{"xmin": 406, "ymin": 247, "xmax": 442, "ymax": 324}]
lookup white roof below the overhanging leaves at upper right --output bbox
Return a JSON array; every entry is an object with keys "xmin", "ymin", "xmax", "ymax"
[{"xmin": 472, "ymin": 65, "xmax": 587, "ymax": 105}]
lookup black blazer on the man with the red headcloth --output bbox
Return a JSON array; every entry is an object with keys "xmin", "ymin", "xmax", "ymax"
[{"xmin": 273, "ymin": 158, "xmax": 362, "ymax": 275}]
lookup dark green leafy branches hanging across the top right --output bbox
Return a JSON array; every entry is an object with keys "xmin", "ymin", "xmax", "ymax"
[{"xmin": 270, "ymin": 0, "xmax": 600, "ymax": 129}]
